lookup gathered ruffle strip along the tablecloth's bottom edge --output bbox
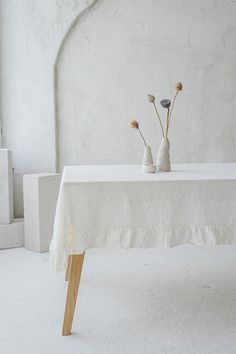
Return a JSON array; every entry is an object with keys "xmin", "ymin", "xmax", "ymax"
[{"xmin": 50, "ymin": 225, "xmax": 236, "ymax": 272}]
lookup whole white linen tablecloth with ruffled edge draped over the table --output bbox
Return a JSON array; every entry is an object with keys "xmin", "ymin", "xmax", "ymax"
[{"xmin": 50, "ymin": 164, "xmax": 236, "ymax": 271}]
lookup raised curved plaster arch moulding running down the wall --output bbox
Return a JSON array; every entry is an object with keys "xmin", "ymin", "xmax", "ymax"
[{"xmin": 53, "ymin": 0, "xmax": 99, "ymax": 172}]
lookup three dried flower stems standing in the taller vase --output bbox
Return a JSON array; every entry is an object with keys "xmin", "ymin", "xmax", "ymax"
[{"xmin": 148, "ymin": 82, "xmax": 183, "ymax": 139}]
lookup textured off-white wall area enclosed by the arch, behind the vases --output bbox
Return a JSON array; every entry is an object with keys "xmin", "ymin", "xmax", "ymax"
[{"xmin": 57, "ymin": 0, "xmax": 236, "ymax": 167}]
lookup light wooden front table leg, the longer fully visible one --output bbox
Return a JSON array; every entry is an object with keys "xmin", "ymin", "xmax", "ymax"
[{"xmin": 62, "ymin": 253, "xmax": 85, "ymax": 336}]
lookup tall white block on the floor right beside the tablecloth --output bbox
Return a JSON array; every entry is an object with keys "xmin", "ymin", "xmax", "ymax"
[{"xmin": 23, "ymin": 173, "xmax": 61, "ymax": 252}]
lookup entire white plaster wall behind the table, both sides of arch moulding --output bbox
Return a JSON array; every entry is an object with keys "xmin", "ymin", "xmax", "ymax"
[{"xmin": 0, "ymin": 0, "xmax": 236, "ymax": 216}]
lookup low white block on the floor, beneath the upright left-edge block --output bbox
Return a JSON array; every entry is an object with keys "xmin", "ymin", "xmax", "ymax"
[{"xmin": 0, "ymin": 219, "xmax": 24, "ymax": 249}]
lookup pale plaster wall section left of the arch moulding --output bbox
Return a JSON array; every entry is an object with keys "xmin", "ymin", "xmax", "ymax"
[{"xmin": 0, "ymin": 0, "xmax": 94, "ymax": 216}]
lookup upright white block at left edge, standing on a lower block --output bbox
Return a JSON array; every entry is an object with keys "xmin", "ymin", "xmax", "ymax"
[{"xmin": 0, "ymin": 149, "xmax": 13, "ymax": 224}]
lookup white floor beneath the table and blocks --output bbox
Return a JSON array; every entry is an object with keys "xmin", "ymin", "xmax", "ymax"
[{"xmin": 0, "ymin": 246, "xmax": 236, "ymax": 354}]
